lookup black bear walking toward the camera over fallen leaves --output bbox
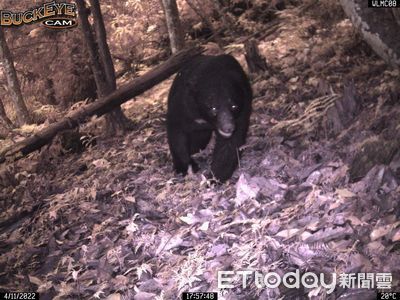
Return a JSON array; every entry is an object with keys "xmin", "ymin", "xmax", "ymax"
[{"xmin": 167, "ymin": 55, "xmax": 252, "ymax": 181}]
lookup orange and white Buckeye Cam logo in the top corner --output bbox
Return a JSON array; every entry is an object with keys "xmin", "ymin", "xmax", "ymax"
[{"xmin": 0, "ymin": 1, "xmax": 77, "ymax": 29}]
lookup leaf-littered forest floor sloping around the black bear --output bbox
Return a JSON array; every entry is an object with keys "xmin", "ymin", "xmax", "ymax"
[{"xmin": 0, "ymin": 3, "xmax": 400, "ymax": 300}]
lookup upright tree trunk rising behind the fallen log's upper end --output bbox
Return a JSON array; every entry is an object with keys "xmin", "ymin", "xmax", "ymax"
[{"xmin": 162, "ymin": 0, "xmax": 184, "ymax": 53}]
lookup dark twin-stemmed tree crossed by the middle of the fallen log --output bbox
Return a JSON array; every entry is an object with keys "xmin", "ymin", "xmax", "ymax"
[{"xmin": 76, "ymin": 0, "xmax": 129, "ymax": 134}]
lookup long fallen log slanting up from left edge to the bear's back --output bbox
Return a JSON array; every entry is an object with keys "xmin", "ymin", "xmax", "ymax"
[{"xmin": 0, "ymin": 47, "xmax": 203, "ymax": 163}]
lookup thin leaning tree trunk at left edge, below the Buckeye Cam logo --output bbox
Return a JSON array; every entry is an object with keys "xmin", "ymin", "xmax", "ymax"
[{"xmin": 0, "ymin": 28, "xmax": 31, "ymax": 125}]
